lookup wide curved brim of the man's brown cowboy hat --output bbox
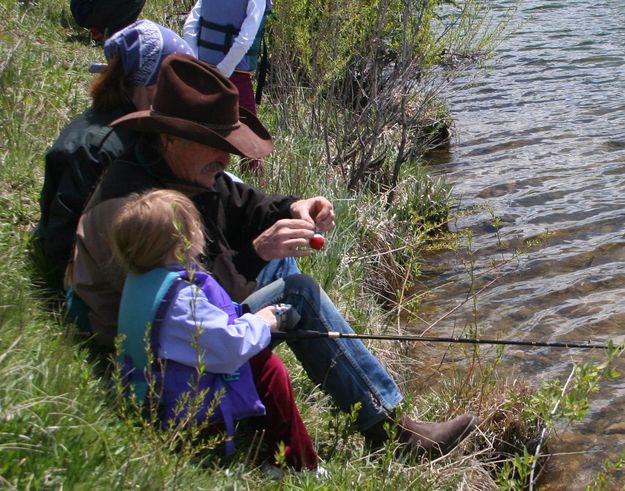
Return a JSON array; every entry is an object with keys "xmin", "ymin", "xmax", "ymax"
[{"xmin": 111, "ymin": 108, "xmax": 273, "ymax": 159}]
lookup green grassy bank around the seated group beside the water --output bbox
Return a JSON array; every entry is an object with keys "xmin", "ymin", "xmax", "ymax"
[{"xmin": 0, "ymin": 0, "xmax": 620, "ymax": 490}]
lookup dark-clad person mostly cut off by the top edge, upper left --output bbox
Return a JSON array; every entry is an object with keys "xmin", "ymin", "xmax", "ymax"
[{"xmin": 70, "ymin": 0, "xmax": 145, "ymax": 43}]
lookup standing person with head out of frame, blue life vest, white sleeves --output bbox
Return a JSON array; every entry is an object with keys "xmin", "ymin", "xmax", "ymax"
[{"xmin": 183, "ymin": 0, "xmax": 271, "ymax": 173}]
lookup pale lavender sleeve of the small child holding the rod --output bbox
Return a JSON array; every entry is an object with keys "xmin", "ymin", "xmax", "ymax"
[{"xmin": 158, "ymin": 285, "xmax": 271, "ymax": 373}]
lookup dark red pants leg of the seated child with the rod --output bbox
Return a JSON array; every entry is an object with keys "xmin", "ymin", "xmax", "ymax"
[{"xmin": 250, "ymin": 349, "xmax": 318, "ymax": 470}]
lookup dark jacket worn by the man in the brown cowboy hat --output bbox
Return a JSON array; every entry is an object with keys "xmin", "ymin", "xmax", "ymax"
[{"xmin": 70, "ymin": 138, "xmax": 296, "ymax": 344}]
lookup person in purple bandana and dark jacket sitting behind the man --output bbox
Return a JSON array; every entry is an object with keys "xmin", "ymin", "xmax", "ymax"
[{"xmin": 33, "ymin": 20, "xmax": 191, "ymax": 292}]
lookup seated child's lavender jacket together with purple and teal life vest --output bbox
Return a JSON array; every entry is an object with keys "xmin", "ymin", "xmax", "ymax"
[{"xmin": 119, "ymin": 268, "xmax": 271, "ymax": 452}]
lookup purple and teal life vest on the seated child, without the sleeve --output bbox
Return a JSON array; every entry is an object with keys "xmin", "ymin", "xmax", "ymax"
[{"xmin": 118, "ymin": 268, "xmax": 265, "ymax": 454}]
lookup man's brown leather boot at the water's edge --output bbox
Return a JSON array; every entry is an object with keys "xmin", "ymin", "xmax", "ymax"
[{"xmin": 363, "ymin": 414, "xmax": 479, "ymax": 458}]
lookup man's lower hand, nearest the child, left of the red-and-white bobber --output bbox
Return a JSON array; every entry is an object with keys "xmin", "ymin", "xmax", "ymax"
[{"xmin": 253, "ymin": 218, "xmax": 315, "ymax": 261}]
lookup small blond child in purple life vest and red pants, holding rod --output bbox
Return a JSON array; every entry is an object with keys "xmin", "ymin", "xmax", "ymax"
[{"xmin": 111, "ymin": 190, "xmax": 318, "ymax": 469}]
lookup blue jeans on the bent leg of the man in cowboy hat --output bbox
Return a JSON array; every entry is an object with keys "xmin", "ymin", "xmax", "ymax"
[{"xmin": 244, "ymin": 274, "xmax": 402, "ymax": 430}]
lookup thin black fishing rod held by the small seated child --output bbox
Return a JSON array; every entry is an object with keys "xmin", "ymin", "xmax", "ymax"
[{"xmin": 271, "ymin": 331, "xmax": 610, "ymax": 350}]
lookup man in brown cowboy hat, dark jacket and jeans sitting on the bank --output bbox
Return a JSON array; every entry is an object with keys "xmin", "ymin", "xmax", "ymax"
[{"xmin": 69, "ymin": 55, "xmax": 476, "ymax": 454}]
